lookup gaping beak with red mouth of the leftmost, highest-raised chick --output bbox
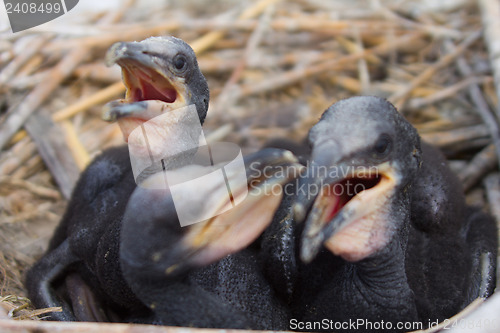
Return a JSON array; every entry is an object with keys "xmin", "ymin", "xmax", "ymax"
[{"xmin": 102, "ymin": 42, "xmax": 190, "ymax": 141}]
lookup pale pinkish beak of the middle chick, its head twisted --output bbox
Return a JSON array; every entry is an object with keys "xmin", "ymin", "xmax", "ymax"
[{"xmin": 143, "ymin": 149, "xmax": 303, "ymax": 274}]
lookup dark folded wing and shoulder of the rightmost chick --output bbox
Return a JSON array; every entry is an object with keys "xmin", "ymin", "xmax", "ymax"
[{"xmin": 406, "ymin": 145, "xmax": 497, "ymax": 323}]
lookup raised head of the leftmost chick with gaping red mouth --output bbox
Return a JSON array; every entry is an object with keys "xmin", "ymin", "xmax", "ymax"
[{"xmin": 102, "ymin": 36, "xmax": 209, "ymax": 141}]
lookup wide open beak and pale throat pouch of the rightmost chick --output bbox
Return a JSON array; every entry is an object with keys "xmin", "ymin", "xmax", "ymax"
[{"xmin": 293, "ymin": 143, "xmax": 399, "ymax": 263}]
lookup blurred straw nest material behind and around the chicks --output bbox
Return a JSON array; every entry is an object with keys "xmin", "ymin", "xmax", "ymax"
[{"xmin": 0, "ymin": 0, "xmax": 500, "ymax": 319}]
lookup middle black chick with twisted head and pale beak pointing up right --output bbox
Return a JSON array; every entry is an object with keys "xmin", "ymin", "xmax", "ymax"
[{"xmin": 120, "ymin": 149, "xmax": 298, "ymax": 330}]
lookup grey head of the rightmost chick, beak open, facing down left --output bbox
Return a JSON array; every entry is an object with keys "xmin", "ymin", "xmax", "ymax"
[{"xmin": 294, "ymin": 97, "xmax": 421, "ymax": 262}]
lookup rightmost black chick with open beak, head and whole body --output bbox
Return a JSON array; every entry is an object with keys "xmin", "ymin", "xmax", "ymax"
[{"xmin": 291, "ymin": 97, "xmax": 497, "ymax": 331}]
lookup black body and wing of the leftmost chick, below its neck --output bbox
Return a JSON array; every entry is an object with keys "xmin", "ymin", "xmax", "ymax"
[{"xmin": 26, "ymin": 146, "xmax": 146, "ymax": 321}]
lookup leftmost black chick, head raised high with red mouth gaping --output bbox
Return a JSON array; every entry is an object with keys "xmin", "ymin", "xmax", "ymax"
[{"xmin": 26, "ymin": 37, "xmax": 209, "ymax": 321}]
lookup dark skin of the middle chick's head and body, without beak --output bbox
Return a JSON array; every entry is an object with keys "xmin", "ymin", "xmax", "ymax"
[{"xmin": 120, "ymin": 184, "xmax": 288, "ymax": 330}]
